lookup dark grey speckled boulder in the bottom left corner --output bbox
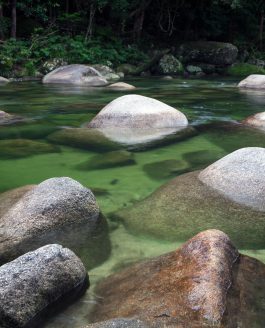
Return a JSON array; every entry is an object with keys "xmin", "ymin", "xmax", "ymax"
[{"xmin": 0, "ymin": 244, "xmax": 89, "ymax": 328}]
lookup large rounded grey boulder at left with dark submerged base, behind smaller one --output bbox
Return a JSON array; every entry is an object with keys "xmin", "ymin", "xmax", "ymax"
[{"xmin": 0, "ymin": 177, "xmax": 110, "ymax": 266}]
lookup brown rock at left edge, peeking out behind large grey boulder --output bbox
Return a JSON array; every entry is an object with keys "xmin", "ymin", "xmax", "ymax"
[{"xmin": 0, "ymin": 185, "xmax": 34, "ymax": 218}]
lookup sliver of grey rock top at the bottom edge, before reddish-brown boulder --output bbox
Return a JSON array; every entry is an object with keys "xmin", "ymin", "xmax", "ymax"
[{"xmin": 85, "ymin": 318, "xmax": 149, "ymax": 328}]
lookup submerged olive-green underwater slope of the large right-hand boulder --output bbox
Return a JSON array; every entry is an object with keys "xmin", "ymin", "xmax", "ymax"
[{"xmin": 113, "ymin": 167, "xmax": 265, "ymax": 249}]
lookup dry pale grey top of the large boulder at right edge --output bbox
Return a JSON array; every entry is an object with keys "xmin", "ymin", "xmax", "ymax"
[{"xmin": 199, "ymin": 147, "xmax": 265, "ymax": 211}]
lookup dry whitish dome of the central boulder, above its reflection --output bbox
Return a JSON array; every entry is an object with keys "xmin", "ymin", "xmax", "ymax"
[{"xmin": 87, "ymin": 95, "xmax": 188, "ymax": 129}]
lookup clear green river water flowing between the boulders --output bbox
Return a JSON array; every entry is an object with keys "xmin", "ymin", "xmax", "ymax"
[{"xmin": 0, "ymin": 78, "xmax": 265, "ymax": 328}]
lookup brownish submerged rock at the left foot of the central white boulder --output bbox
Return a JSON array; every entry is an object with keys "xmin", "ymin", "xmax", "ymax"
[{"xmin": 48, "ymin": 128, "xmax": 120, "ymax": 151}]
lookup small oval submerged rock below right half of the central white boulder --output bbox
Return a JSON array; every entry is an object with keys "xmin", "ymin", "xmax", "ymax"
[{"xmin": 143, "ymin": 159, "xmax": 188, "ymax": 180}]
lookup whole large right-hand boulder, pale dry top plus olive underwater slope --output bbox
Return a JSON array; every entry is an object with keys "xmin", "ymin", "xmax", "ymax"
[{"xmin": 112, "ymin": 148, "xmax": 265, "ymax": 249}]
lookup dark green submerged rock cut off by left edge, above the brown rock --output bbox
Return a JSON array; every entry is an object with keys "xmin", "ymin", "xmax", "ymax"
[{"xmin": 0, "ymin": 139, "xmax": 60, "ymax": 159}]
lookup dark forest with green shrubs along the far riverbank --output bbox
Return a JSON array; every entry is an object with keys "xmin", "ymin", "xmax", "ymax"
[{"xmin": 0, "ymin": 0, "xmax": 265, "ymax": 75}]
